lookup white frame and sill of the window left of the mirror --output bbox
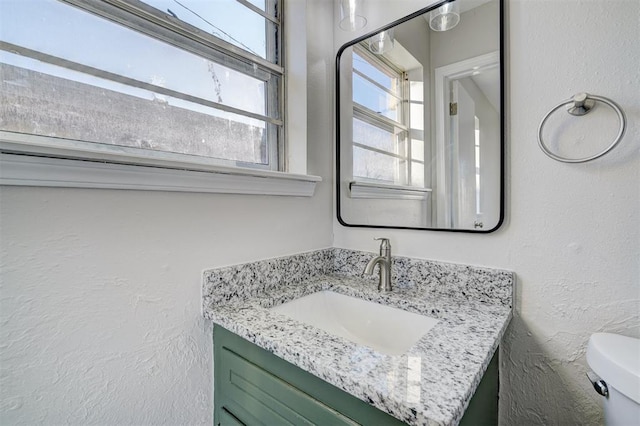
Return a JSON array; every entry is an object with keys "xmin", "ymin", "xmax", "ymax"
[{"xmin": 0, "ymin": 0, "xmax": 321, "ymax": 196}]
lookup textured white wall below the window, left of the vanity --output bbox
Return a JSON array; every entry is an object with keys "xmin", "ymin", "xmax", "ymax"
[{"xmin": 0, "ymin": 2, "xmax": 333, "ymax": 425}]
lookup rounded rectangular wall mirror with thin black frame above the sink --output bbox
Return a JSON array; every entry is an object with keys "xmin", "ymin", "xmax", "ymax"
[{"xmin": 336, "ymin": 0, "xmax": 504, "ymax": 232}]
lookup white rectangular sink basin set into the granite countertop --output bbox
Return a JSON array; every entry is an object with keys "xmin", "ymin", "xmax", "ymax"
[{"xmin": 271, "ymin": 291, "xmax": 438, "ymax": 355}]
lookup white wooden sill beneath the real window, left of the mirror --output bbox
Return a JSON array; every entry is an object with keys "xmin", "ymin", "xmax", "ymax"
[{"xmin": 0, "ymin": 152, "xmax": 322, "ymax": 197}]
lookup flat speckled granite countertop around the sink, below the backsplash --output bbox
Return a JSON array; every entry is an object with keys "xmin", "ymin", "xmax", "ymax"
[{"xmin": 203, "ymin": 250, "xmax": 512, "ymax": 425}]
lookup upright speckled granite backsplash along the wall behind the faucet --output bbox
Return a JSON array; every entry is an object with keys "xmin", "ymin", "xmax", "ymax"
[{"xmin": 202, "ymin": 248, "xmax": 515, "ymax": 316}]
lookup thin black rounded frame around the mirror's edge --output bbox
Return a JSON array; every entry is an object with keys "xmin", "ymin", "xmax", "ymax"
[{"xmin": 335, "ymin": 0, "xmax": 506, "ymax": 234}]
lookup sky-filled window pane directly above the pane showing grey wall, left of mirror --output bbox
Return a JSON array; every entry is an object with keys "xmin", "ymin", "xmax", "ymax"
[{"xmin": 2, "ymin": 0, "xmax": 267, "ymax": 115}]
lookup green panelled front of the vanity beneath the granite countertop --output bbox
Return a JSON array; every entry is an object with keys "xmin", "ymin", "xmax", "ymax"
[{"xmin": 214, "ymin": 326, "xmax": 497, "ymax": 426}]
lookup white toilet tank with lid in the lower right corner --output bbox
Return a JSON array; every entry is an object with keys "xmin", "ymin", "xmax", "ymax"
[{"xmin": 587, "ymin": 333, "xmax": 640, "ymax": 426}]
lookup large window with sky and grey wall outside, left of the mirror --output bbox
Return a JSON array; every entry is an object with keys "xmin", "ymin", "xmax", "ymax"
[{"xmin": 0, "ymin": 0, "xmax": 285, "ymax": 171}]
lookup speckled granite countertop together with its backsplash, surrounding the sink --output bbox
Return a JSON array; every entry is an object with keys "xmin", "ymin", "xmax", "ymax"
[{"xmin": 203, "ymin": 248, "xmax": 514, "ymax": 425}]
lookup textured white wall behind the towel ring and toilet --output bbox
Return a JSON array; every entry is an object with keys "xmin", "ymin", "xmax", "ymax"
[{"xmin": 334, "ymin": 0, "xmax": 640, "ymax": 425}]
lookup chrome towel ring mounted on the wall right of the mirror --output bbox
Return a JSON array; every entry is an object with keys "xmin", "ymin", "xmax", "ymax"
[{"xmin": 538, "ymin": 93, "xmax": 627, "ymax": 163}]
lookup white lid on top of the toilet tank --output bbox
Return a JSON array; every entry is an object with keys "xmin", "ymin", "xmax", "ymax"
[{"xmin": 587, "ymin": 333, "xmax": 640, "ymax": 404}]
